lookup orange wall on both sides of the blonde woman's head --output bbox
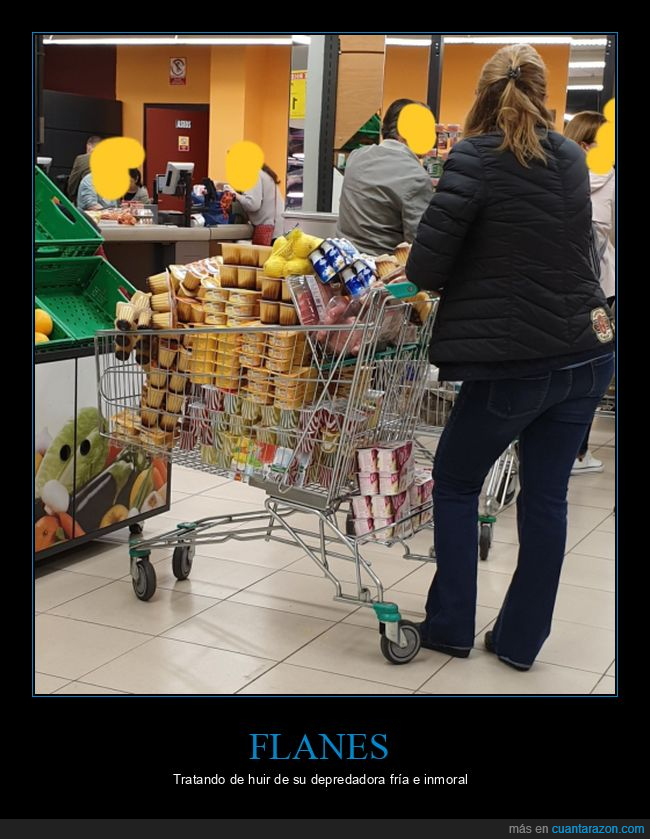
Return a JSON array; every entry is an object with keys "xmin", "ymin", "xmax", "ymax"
[{"xmin": 436, "ymin": 44, "xmax": 570, "ymax": 131}]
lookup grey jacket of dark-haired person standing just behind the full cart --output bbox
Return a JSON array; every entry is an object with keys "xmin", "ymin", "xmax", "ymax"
[{"xmin": 337, "ymin": 140, "xmax": 433, "ymax": 255}]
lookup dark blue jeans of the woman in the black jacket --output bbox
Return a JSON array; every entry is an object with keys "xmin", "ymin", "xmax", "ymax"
[{"xmin": 422, "ymin": 355, "xmax": 614, "ymax": 666}]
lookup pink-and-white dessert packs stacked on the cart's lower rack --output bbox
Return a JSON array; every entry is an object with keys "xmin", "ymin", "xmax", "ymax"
[{"xmin": 352, "ymin": 440, "xmax": 433, "ymax": 541}]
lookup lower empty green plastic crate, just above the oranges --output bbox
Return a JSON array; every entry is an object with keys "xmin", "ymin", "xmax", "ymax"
[{"xmin": 34, "ymin": 256, "xmax": 135, "ymax": 341}]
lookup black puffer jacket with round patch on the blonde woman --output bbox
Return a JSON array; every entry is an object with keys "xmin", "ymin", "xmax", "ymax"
[{"xmin": 406, "ymin": 132, "xmax": 612, "ymax": 366}]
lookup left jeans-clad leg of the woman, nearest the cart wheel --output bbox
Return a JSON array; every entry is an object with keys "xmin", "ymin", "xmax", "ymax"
[{"xmin": 421, "ymin": 374, "xmax": 548, "ymax": 655}]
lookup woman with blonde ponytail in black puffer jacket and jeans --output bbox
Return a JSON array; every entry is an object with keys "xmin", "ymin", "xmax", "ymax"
[{"xmin": 406, "ymin": 45, "xmax": 613, "ymax": 670}]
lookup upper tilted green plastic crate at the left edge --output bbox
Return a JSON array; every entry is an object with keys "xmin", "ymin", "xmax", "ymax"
[{"xmin": 34, "ymin": 166, "xmax": 104, "ymax": 258}]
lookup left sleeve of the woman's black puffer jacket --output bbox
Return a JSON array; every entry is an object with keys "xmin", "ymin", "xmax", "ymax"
[{"xmin": 406, "ymin": 140, "xmax": 484, "ymax": 291}]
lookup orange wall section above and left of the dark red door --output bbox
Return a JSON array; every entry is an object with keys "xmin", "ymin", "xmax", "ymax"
[{"xmin": 115, "ymin": 46, "xmax": 210, "ymax": 142}]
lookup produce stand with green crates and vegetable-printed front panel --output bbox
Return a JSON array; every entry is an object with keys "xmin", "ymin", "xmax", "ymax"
[{"xmin": 34, "ymin": 168, "xmax": 169, "ymax": 558}]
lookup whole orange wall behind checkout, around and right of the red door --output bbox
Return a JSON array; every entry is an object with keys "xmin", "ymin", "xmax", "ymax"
[{"xmin": 115, "ymin": 46, "xmax": 291, "ymax": 195}]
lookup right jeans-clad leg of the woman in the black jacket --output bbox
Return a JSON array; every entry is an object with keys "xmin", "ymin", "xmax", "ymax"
[{"xmin": 491, "ymin": 359, "xmax": 613, "ymax": 668}]
